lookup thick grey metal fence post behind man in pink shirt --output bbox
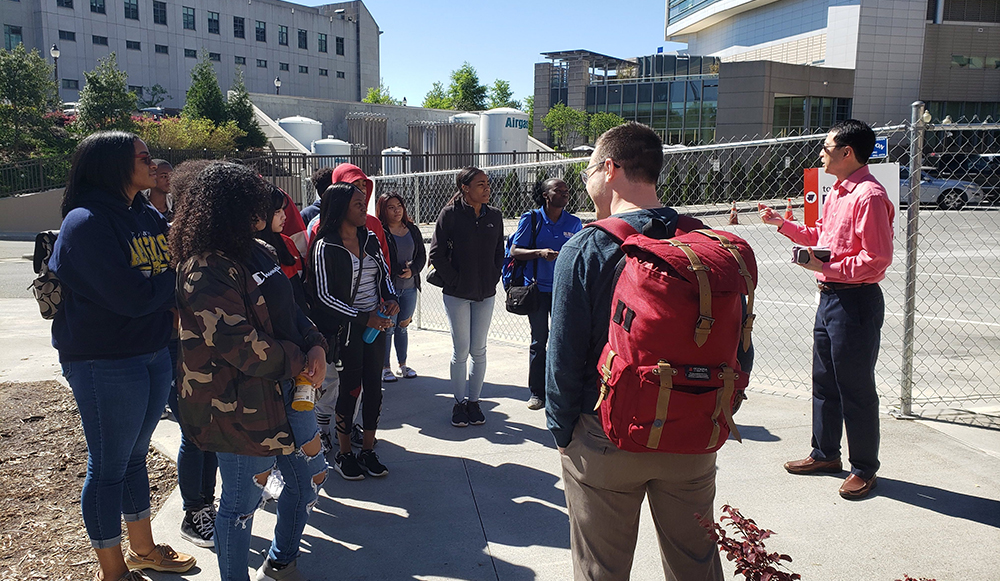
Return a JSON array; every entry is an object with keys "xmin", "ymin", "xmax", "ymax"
[{"xmin": 899, "ymin": 101, "xmax": 927, "ymax": 417}]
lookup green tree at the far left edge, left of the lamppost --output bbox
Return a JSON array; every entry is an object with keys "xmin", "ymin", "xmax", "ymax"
[{"xmin": 0, "ymin": 44, "xmax": 59, "ymax": 157}]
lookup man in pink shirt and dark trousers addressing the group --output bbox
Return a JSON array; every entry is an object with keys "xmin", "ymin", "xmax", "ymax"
[{"xmin": 758, "ymin": 119, "xmax": 895, "ymax": 500}]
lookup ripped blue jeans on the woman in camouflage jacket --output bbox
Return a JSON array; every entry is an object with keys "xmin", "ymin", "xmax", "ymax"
[{"xmin": 215, "ymin": 448, "xmax": 326, "ymax": 581}]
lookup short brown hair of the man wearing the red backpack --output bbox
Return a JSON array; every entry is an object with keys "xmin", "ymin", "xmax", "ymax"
[{"xmin": 591, "ymin": 121, "xmax": 663, "ymax": 184}]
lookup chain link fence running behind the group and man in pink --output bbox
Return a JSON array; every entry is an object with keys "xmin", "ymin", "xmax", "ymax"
[{"xmin": 375, "ymin": 110, "xmax": 1000, "ymax": 427}]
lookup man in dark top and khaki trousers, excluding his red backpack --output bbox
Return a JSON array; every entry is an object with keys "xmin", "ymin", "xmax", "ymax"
[{"xmin": 545, "ymin": 123, "xmax": 723, "ymax": 581}]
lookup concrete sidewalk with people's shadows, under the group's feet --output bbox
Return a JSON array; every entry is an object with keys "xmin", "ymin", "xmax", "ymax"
[{"xmin": 0, "ymin": 299, "xmax": 1000, "ymax": 581}]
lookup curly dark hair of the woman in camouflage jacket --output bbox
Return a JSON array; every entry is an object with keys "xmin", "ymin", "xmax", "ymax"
[{"xmin": 170, "ymin": 161, "xmax": 271, "ymax": 265}]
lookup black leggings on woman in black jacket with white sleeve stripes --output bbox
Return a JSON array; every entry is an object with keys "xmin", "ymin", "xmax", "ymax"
[{"xmin": 336, "ymin": 322, "xmax": 385, "ymax": 434}]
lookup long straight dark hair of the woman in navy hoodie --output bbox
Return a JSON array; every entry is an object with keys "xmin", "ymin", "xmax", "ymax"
[{"xmin": 62, "ymin": 131, "xmax": 139, "ymax": 218}]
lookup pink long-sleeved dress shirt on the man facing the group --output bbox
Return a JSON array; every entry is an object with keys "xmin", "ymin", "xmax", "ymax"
[{"xmin": 778, "ymin": 165, "xmax": 896, "ymax": 283}]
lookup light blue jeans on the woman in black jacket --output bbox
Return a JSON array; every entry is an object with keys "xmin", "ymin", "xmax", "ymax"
[{"xmin": 444, "ymin": 295, "xmax": 496, "ymax": 402}]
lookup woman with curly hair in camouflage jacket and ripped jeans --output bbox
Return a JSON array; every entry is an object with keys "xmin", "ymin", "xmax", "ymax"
[{"xmin": 170, "ymin": 162, "xmax": 326, "ymax": 581}]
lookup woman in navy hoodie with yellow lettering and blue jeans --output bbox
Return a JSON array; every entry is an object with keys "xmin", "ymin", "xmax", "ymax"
[{"xmin": 49, "ymin": 131, "xmax": 195, "ymax": 581}]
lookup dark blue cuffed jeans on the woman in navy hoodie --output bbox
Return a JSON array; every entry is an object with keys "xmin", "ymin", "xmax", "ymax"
[{"xmin": 62, "ymin": 347, "xmax": 171, "ymax": 549}]
